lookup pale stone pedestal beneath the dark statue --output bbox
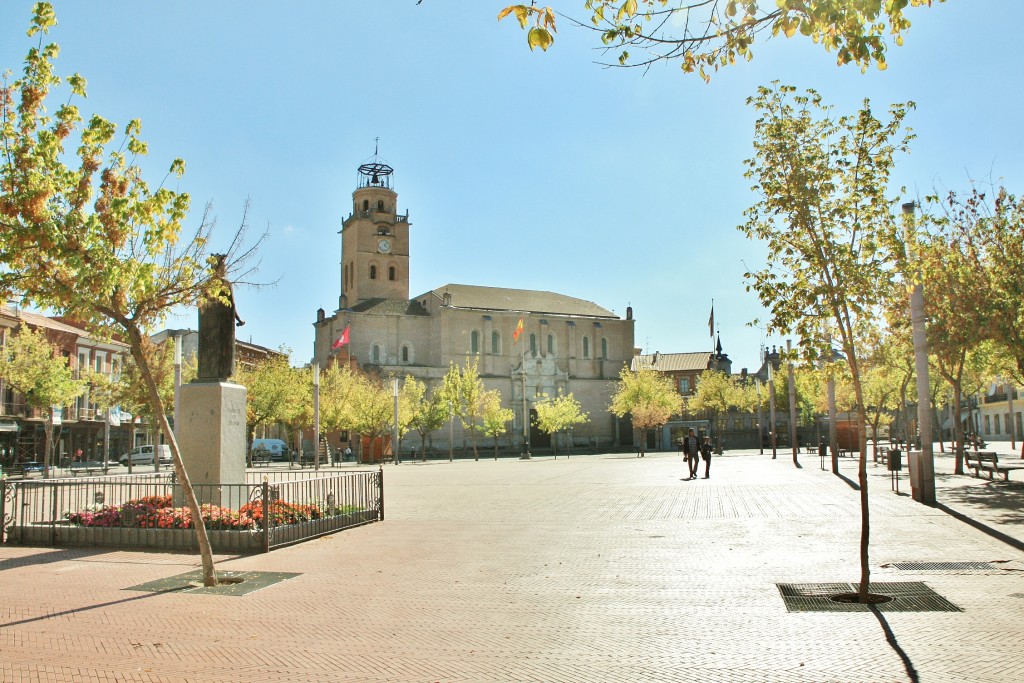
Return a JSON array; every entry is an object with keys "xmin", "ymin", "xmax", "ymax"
[{"xmin": 175, "ymin": 382, "xmax": 248, "ymax": 510}]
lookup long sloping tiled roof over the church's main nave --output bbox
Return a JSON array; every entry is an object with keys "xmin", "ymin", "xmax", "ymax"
[{"xmin": 423, "ymin": 284, "xmax": 618, "ymax": 319}]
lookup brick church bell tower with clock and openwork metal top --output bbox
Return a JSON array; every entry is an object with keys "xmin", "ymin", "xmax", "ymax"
[{"xmin": 339, "ymin": 154, "xmax": 411, "ymax": 308}]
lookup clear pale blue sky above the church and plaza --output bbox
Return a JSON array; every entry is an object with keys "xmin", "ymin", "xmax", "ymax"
[{"xmin": 0, "ymin": 0, "xmax": 1024, "ymax": 371}]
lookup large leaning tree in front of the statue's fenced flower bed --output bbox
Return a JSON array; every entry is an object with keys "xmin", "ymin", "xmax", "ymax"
[{"xmin": 0, "ymin": 2, "xmax": 258, "ymax": 586}]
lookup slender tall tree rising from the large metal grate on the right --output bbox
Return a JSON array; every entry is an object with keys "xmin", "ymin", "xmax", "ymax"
[{"xmin": 740, "ymin": 83, "xmax": 912, "ymax": 602}]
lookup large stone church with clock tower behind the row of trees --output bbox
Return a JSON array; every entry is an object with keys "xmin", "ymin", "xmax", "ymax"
[{"xmin": 313, "ymin": 157, "xmax": 636, "ymax": 449}]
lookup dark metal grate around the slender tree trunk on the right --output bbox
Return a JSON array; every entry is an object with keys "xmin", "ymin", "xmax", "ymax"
[{"xmin": 776, "ymin": 582, "xmax": 964, "ymax": 612}]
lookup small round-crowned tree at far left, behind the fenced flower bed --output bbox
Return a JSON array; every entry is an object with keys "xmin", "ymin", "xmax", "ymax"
[{"xmin": 0, "ymin": 325, "xmax": 86, "ymax": 477}]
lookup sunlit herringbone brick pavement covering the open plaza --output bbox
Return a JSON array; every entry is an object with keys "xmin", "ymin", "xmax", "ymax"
[{"xmin": 0, "ymin": 452, "xmax": 1024, "ymax": 683}]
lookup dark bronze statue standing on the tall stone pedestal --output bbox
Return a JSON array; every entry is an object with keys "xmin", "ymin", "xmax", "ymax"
[{"xmin": 196, "ymin": 254, "xmax": 245, "ymax": 382}]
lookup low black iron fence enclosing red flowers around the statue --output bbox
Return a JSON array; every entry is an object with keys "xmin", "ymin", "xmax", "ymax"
[{"xmin": 0, "ymin": 469, "xmax": 384, "ymax": 554}]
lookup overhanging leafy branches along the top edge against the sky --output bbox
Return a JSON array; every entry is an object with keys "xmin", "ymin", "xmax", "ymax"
[{"xmin": 498, "ymin": 0, "xmax": 944, "ymax": 81}]
